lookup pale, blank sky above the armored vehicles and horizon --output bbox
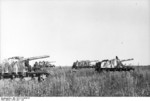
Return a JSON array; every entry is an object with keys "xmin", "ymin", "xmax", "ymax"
[{"xmin": 0, "ymin": 0, "xmax": 150, "ymax": 65}]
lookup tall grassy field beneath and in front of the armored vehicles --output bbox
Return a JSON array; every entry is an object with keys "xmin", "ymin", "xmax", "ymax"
[{"xmin": 0, "ymin": 66, "xmax": 150, "ymax": 97}]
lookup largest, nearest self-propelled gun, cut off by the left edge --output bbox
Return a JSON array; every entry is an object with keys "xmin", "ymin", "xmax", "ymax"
[{"xmin": 0, "ymin": 55, "xmax": 49, "ymax": 81}]
